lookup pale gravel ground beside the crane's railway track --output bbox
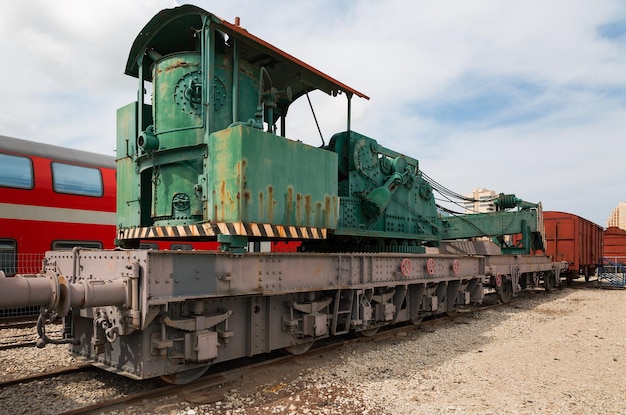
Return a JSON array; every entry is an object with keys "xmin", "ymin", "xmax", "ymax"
[{"xmin": 0, "ymin": 288, "xmax": 626, "ymax": 415}]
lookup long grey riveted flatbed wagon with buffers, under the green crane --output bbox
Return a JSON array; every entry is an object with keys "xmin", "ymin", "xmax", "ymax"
[{"xmin": 3, "ymin": 250, "xmax": 484, "ymax": 383}]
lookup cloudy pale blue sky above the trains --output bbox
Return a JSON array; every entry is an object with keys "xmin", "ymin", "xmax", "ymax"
[{"xmin": 0, "ymin": 0, "xmax": 626, "ymax": 226}]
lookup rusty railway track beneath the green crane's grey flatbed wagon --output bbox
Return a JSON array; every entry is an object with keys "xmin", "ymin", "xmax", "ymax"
[{"xmin": 0, "ymin": 290, "xmax": 560, "ymax": 414}]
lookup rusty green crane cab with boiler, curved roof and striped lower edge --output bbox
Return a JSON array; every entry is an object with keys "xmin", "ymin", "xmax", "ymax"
[{"xmin": 117, "ymin": 6, "xmax": 352, "ymax": 248}]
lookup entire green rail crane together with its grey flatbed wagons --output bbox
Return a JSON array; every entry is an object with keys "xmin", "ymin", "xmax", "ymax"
[{"xmin": 0, "ymin": 5, "xmax": 562, "ymax": 383}]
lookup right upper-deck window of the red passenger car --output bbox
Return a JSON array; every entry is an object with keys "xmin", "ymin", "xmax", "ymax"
[{"xmin": 52, "ymin": 162, "xmax": 103, "ymax": 197}]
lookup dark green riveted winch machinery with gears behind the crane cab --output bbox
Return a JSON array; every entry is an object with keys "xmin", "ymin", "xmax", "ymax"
[{"xmin": 330, "ymin": 132, "xmax": 441, "ymax": 247}]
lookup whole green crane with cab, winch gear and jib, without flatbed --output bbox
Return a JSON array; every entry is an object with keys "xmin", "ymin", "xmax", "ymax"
[{"xmin": 117, "ymin": 5, "xmax": 539, "ymax": 253}]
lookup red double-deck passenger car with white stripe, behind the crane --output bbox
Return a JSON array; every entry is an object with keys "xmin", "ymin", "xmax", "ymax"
[{"xmin": 0, "ymin": 136, "xmax": 299, "ymax": 282}]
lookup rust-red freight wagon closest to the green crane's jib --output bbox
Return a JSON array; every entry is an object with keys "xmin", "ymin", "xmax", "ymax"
[{"xmin": 543, "ymin": 211, "xmax": 604, "ymax": 281}]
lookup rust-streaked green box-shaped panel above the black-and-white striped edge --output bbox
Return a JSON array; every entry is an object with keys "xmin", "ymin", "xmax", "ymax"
[{"xmin": 205, "ymin": 125, "xmax": 338, "ymax": 229}]
